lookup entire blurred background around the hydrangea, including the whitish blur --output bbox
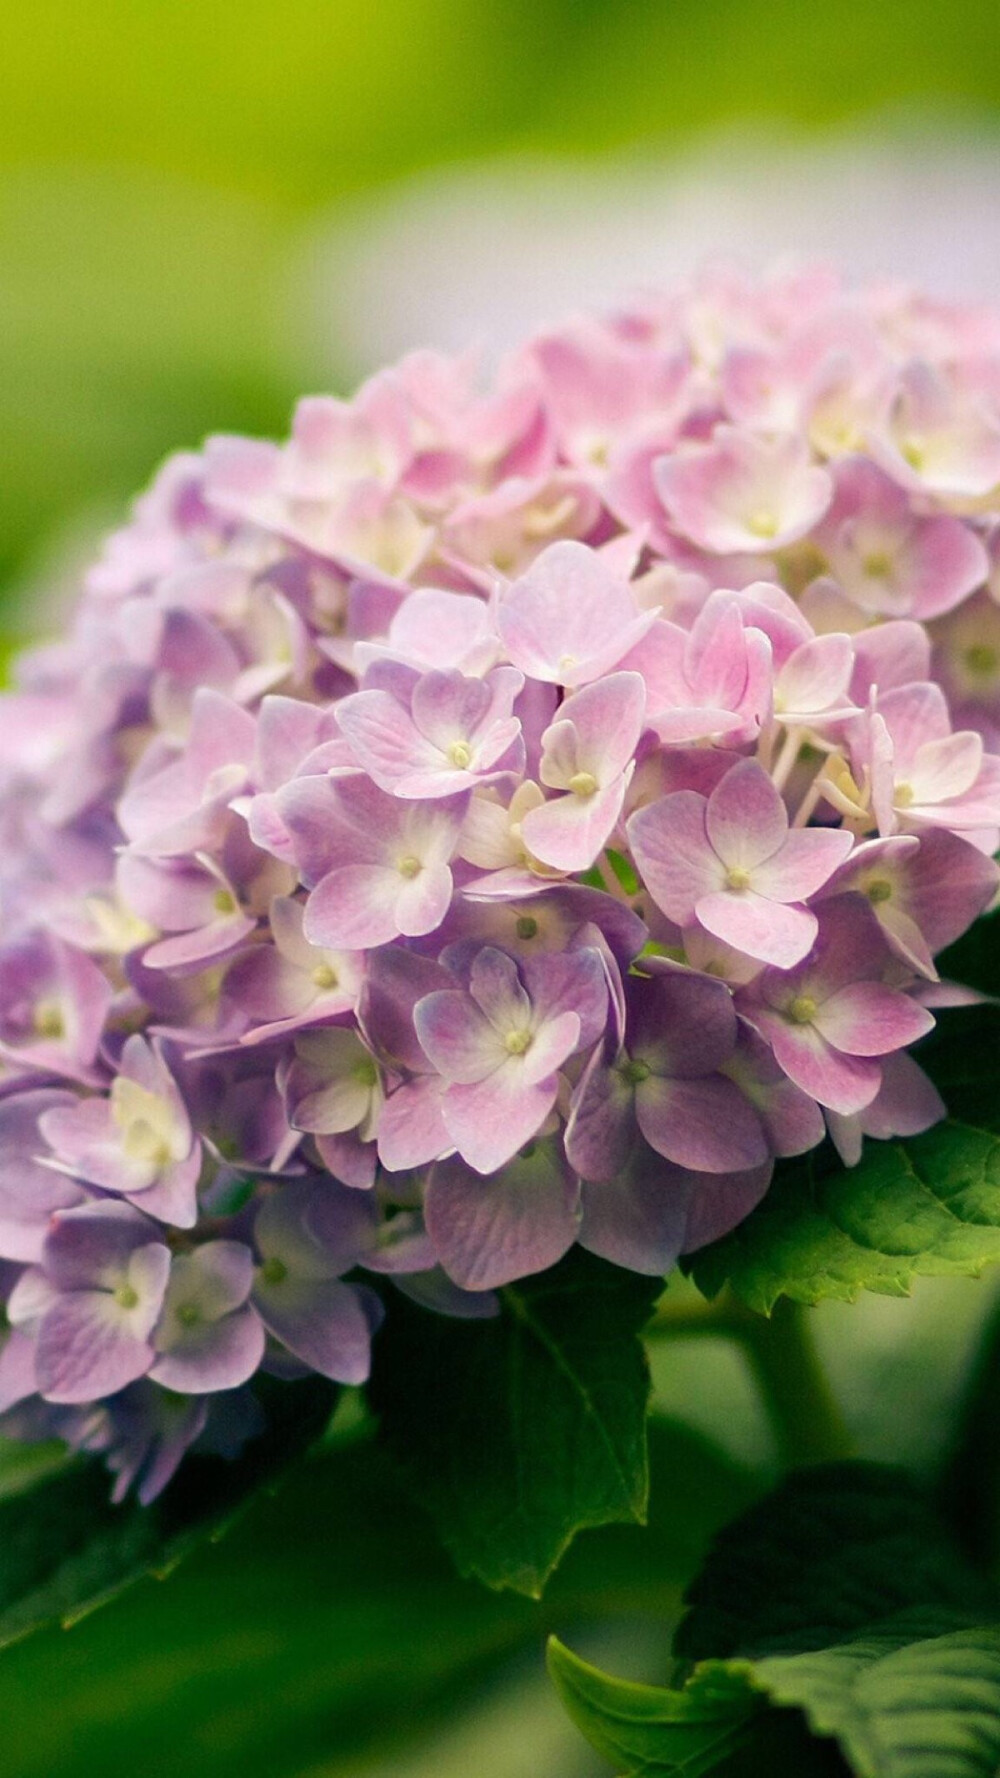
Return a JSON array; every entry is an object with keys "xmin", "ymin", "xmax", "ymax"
[{"xmin": 0, "ymin": 0, "xmax": 1000, "ymax": 1778}]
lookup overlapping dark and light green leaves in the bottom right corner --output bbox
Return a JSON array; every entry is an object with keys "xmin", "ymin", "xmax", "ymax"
[{"xmin": 550, "ymin": 1465, "xmax": 1000, "ymax": 1778}]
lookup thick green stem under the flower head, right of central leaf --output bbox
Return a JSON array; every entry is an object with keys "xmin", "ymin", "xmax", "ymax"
[{"xmin": 648, "ymin": 1293, "xmax": 851, "ymax": 1469}]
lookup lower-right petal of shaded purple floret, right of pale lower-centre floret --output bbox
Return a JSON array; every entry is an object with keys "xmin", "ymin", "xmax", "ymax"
[{"xmin": 635, "ymin": 1074, "xmax": 769, "ymax": 1173}]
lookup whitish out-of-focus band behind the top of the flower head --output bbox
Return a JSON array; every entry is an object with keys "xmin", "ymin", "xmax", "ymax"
[{"xmin": 295, "ymin": 117, "xmax": 1000, "ymax": 372}]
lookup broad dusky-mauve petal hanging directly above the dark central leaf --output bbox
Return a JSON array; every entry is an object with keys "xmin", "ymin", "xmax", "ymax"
[{"xmin": 423, "ymin": 1141, "xmax": 580, "ymax": 1291}]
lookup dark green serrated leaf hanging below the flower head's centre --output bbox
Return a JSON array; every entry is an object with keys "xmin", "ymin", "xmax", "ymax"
[{"xmin": 372, "ymin": 1253, "xmax": 662, "ymax": 1597}]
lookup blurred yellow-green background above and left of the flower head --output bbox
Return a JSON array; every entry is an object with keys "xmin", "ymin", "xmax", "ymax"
[{"xmin": 0, "ymin": 0, "xmax": 1000, "ymax": 628}]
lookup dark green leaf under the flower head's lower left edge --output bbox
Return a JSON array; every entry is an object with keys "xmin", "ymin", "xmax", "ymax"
[{"xmin": 0, "ymin": 1382, "xmax": 336, "ymax": 1646}]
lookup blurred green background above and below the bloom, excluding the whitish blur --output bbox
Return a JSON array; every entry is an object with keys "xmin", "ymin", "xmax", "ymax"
[{"xmin": 0, "ymin": 0, "xmax": 1000, "ymax": 1778}]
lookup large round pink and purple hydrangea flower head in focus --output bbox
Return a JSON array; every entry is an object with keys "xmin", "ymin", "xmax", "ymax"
[{"xmin": 0, "ymin": 270, "xmax": 1000, "ymax": 1497}]
